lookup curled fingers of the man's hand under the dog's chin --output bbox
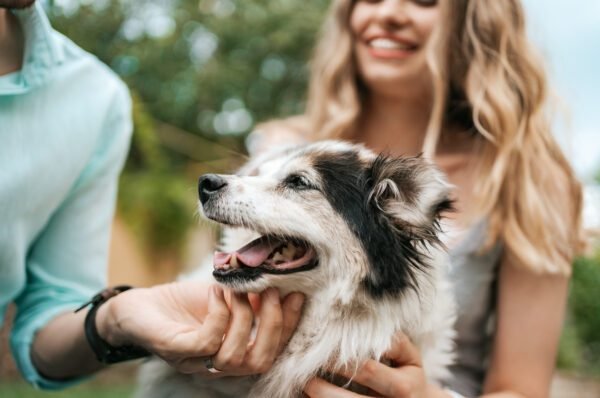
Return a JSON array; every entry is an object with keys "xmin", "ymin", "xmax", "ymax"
[{"xmin": 159, "ymin": 286, "xmax": 304, "ymax": 376}]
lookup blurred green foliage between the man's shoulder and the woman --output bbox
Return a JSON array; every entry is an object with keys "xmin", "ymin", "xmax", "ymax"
[{"xmin": 49, "ymin": 0, "xmax": 329, "ymax": 251}]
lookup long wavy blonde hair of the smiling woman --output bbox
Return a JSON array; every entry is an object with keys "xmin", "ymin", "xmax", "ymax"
[{"xmin": 262, "ymin": 0, "xmax": 582, "ymax": 274}]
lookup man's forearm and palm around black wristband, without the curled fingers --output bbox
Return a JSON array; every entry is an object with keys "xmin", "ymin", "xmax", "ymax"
[{"xmin": 31, "ymin": 282, "xmax": 229, "ymax": 381}]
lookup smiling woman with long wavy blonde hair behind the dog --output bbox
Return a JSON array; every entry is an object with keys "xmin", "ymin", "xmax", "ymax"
[{"xmin": 249, "ymin": 0, "xmax": 581, "ymax": 398}]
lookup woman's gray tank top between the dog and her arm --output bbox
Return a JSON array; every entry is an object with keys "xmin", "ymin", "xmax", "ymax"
[{"xmin": 445, "ymin": 221, "xmax": 502, "ymax": 397}]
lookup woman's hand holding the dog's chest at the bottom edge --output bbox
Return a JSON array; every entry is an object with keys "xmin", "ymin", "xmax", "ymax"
[{"xmin": 304, "ymin": 334, "xmax": 448, "ymax": 398}]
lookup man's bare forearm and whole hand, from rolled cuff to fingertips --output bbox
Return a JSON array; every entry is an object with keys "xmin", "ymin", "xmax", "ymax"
[{"xmin": 32, "ymin": 281, "xmax": 303, "ymax": 380}]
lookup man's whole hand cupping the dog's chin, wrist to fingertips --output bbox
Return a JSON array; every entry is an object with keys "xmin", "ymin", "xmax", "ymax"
[{"xmin": 96, "ymin": 282, "xmax": 303, "ymax": 376}]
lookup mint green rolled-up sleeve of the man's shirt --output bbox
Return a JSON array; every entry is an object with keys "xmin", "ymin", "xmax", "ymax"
[{"xmin": 11, "ymin": 79, "xmax": 132, "ymax": 389}]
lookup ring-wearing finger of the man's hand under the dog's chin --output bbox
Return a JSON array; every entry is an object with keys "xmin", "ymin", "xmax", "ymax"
[{"xmin": 213, "ymin": 293, "xmax": 254, "ymax": 370}]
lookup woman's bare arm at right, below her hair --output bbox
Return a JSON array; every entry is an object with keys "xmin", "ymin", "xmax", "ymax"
[{"xmin": 484, "ymin": 255, "xmax": 569, "ymax": 398}]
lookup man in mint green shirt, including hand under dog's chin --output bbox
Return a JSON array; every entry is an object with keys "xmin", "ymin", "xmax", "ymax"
[{"xmin": 0, "ymin": 0, "xmax": 302, "ymax": 389}]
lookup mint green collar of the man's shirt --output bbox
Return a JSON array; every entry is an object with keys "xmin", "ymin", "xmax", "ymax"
[{"xmin": 0, "ymin": 0, "xmax": 64, "ymax": 95}]
